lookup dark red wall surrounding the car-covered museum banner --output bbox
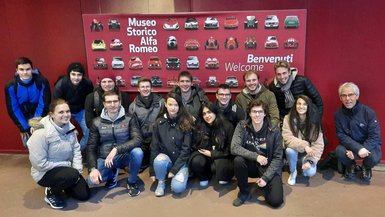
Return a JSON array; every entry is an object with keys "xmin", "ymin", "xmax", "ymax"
[{"xmin": 0, "ymin": 0, "xmax": 385, "ymax": 159}]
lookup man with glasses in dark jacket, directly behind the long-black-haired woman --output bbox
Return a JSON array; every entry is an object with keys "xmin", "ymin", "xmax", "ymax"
[{"xmin": 215, "ymin": 84, "xmax": 245, "ymax": 128}]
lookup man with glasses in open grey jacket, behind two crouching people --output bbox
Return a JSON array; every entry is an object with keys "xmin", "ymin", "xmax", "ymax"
[{"xmin": 129, "ymin": 78, "xmax": 164, "ymax": 170}]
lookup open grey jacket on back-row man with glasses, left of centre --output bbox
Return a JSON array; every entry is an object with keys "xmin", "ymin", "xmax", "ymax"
[{"xmin": 128, "ymin": 93, "xmax": 164, "ymax": 138}]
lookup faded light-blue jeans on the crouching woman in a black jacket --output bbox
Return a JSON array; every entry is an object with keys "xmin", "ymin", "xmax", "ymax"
[{"xmin": 154, "ymin": 154, "xmax": 188, "ymax": 193}]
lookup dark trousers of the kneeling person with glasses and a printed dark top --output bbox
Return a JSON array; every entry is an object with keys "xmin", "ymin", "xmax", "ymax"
[{"xmin": 234, "ymin": 156, "xmax": 283, "ymax": 207}]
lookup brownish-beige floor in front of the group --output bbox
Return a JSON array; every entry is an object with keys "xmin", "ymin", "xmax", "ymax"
[{"xmin": 0, "ymin": 154, "xmax": 385, "ymax": 217}]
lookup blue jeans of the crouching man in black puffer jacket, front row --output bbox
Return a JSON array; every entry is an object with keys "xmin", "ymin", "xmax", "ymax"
[{"xmin": 87, "ymin": 147, "xmax": 143, "ymax": 187}]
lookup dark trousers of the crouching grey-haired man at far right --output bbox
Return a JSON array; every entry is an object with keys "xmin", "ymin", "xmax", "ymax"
[{"xmin": 336, "ymin": 145, "xmax": 381, "ymax": 168}]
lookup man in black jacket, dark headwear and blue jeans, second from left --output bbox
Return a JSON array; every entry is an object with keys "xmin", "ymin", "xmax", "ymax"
[{"xmin": 53, "ymin": 63, "xmax": 94, "ymax": 150}]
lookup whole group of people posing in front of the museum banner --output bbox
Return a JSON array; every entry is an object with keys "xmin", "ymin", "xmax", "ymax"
[{"xmin": 5, "ymin": 57, "xmax": 382, "ymax": 209}]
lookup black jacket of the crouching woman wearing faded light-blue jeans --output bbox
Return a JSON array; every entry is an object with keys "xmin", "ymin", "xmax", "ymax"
[{"xmin": 150, "ymin": 115, "xmax": 192, "ymax": 176}]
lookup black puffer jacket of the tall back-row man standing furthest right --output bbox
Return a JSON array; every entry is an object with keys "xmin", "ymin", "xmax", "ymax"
[{"xmin": 269, "ymin": 75, "xmax": 324, "ymax": 120}]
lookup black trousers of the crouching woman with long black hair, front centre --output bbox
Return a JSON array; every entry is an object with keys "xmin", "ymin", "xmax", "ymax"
[{"xmin": 190, "ymin": 154, "xmax": 234, "ymax": 181}]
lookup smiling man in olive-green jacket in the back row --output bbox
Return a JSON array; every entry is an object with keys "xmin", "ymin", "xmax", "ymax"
[{"xmin": 235, "ymin": 71, "xmax": 279, "ymax": 126}]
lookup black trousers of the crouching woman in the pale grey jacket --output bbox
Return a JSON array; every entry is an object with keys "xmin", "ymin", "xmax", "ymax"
[{"xmin": 37, "ymin": 167, "xmax": 91, "ymax": 201}]
